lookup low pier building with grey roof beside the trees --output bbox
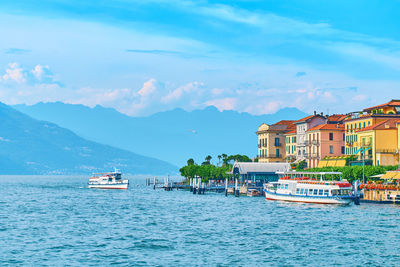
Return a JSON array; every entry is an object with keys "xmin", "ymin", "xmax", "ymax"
[{"xmin": 229, "ymin": 162, "xmax": 290, "ymax": 185}]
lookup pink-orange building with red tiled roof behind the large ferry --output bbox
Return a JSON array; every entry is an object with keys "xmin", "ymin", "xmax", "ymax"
[{"xmin": 306, "ymin": 123, "xmax": 345, "ymax": 168}]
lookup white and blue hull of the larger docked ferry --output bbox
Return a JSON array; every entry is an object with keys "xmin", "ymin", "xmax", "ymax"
[{"xmin": 264, "ymin": 190, "xmax": 353, "ymax": 205}]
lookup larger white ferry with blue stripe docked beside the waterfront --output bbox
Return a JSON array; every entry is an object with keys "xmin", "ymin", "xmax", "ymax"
[{"xmin": 263, "ymin": 172, "xmax": 355, "ymax": 205}]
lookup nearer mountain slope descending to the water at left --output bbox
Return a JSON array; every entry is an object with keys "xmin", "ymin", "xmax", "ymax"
[{"xmin": 0, "ymin": 103, "xmax": 177, "ymax": 174}]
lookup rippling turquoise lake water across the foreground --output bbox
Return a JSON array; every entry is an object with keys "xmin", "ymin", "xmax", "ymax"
[{"xmin": 0, "ymin": 176, "xmax": 400, "ymax": 266}]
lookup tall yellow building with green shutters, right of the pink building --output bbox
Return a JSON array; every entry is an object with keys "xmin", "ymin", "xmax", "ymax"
[{"xmin": 344, "ymin": 100, "xmax": 400, "ymax": 165}]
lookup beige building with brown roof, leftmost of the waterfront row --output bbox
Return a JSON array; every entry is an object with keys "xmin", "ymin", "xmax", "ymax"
[{"xmin": 257, "ymin": 120, "xmax": 295, "ymax": 162}]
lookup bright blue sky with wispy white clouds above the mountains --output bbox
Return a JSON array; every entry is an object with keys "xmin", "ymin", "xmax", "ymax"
[{"xmin": 0, "ymin": 0, "xmax": 400, "ymax": 116}]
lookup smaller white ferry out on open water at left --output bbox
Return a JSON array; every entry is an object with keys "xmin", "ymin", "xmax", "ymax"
[{"xmin": 88, "ymin": 169, "xmax": 129, "ymax": 189}]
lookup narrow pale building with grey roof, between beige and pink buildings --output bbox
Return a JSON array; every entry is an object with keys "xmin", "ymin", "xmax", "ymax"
[{"xmin": 294, "ymin": 111, "xmax": 327, "ymax": 162}]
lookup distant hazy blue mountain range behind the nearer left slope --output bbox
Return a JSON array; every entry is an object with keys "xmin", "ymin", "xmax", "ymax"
[{"xmin": 14, "ymin": 102, "xmax": 307, "ymax": 165}]
